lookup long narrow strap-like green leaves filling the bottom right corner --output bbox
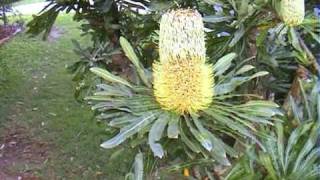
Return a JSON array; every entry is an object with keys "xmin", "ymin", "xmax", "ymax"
[{"xmin": 225, "ymin": 75, "xmax": 320, "ymax": 180}]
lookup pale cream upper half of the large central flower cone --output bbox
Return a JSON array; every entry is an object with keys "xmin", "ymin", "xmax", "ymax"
[{"xmin": 159, "ymin": 9, "xmax": 206, "ymax": 62}]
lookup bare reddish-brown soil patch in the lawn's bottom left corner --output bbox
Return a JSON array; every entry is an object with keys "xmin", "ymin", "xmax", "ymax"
[{"xmin": 0, "ymin": 126, "xmax": 47, "ymax": 180}]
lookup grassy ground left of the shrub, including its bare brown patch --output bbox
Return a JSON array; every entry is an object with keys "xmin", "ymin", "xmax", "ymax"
[{"xmin": 0, "ymin": 15, "xmax": 134, "ymax": 180}]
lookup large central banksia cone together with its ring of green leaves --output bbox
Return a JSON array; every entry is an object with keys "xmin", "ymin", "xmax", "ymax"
[{"xmin": 86, "ymin": 9, "xmax": 279, "ymax": 176}]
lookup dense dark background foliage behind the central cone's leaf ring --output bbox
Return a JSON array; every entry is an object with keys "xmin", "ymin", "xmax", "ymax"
[{"xmin": 23, "ymin": 0, "xmax": 320, "ymax": 179}]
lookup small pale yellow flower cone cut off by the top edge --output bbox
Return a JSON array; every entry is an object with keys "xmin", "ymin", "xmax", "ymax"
[{"xmin": 280, "ymin": 0, "xmax": 305, "ymax": 26}]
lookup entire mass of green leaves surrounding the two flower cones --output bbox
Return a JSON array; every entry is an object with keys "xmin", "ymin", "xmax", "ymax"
[{"xmin": 24, "ymin": 0, "xmax": 320, "ymax": 179}]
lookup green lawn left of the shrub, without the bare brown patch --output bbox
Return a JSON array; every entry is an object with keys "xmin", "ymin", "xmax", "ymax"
[{"xmin": 0, "ymin": 15, "xmax": 132, "ymax": 180}]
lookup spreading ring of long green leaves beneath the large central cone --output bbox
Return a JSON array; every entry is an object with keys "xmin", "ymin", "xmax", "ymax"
[{"xmin": 86, "ymin": 37, "xmax": 281, "ymax": 177}]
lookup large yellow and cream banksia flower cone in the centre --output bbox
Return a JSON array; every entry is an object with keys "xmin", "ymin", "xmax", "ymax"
[{"xmin": 153, "ymin": 9, "xmax": 214, "ymax": 114}]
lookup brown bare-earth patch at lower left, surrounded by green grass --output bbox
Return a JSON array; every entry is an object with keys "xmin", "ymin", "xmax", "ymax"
[{"xmin": 0, "ymin": 105, "xmax": 49, "ymax": 180}]
